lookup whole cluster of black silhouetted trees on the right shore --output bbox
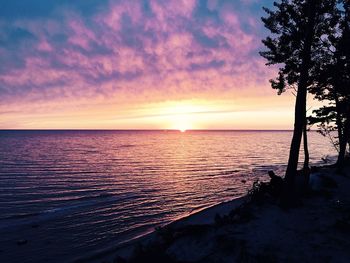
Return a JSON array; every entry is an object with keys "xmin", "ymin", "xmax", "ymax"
[{"xmin": 260, "ymin": 0, "xmax": 350, "ymax": 203}]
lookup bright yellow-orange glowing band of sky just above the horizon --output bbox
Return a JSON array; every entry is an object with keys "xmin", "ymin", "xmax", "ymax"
[{"xmin": 0, "ymin": 90, "xmax": 326, "ymax": 131}]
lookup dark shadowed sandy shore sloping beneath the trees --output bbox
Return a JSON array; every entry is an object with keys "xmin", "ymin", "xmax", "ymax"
[{"xmin": 84, "ymin": 168, "xmax": 350, "ymax": 262}]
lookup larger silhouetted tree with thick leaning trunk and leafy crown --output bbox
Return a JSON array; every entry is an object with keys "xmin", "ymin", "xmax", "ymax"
[{"xmin": 260, "ymin": 0, "xmax": 336, "ymax": 197}]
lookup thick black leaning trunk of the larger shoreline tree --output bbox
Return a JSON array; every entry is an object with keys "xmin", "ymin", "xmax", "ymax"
[{"xmin": 283, "ymin": 0, "xmax": 316, "ymax": 205}]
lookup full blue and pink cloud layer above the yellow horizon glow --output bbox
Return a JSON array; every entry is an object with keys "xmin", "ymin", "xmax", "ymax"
[{"xmin": 0, "ymin": 0, "xmax": 272, "ymax": 111}]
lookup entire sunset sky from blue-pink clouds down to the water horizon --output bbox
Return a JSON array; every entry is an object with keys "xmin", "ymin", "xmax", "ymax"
[{"xmin": 0, "ymin": 0, "xmax": 314, "ymax": 130}]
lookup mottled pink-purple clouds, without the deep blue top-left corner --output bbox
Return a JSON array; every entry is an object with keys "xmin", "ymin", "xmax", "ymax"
[{"xmin": 0, "ymin": 0, "xmax": 272, "ymax": 113}]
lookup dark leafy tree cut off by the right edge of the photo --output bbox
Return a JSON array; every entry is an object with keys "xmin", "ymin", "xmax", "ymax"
[{"xmin": 309, "ymin": 0, "xmax": 350, "ymax": 168}]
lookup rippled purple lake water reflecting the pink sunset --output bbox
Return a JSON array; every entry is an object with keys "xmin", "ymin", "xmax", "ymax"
[{"xmin": 0, "ymin": 131, "xmax": 335, "ymax": 262}]
